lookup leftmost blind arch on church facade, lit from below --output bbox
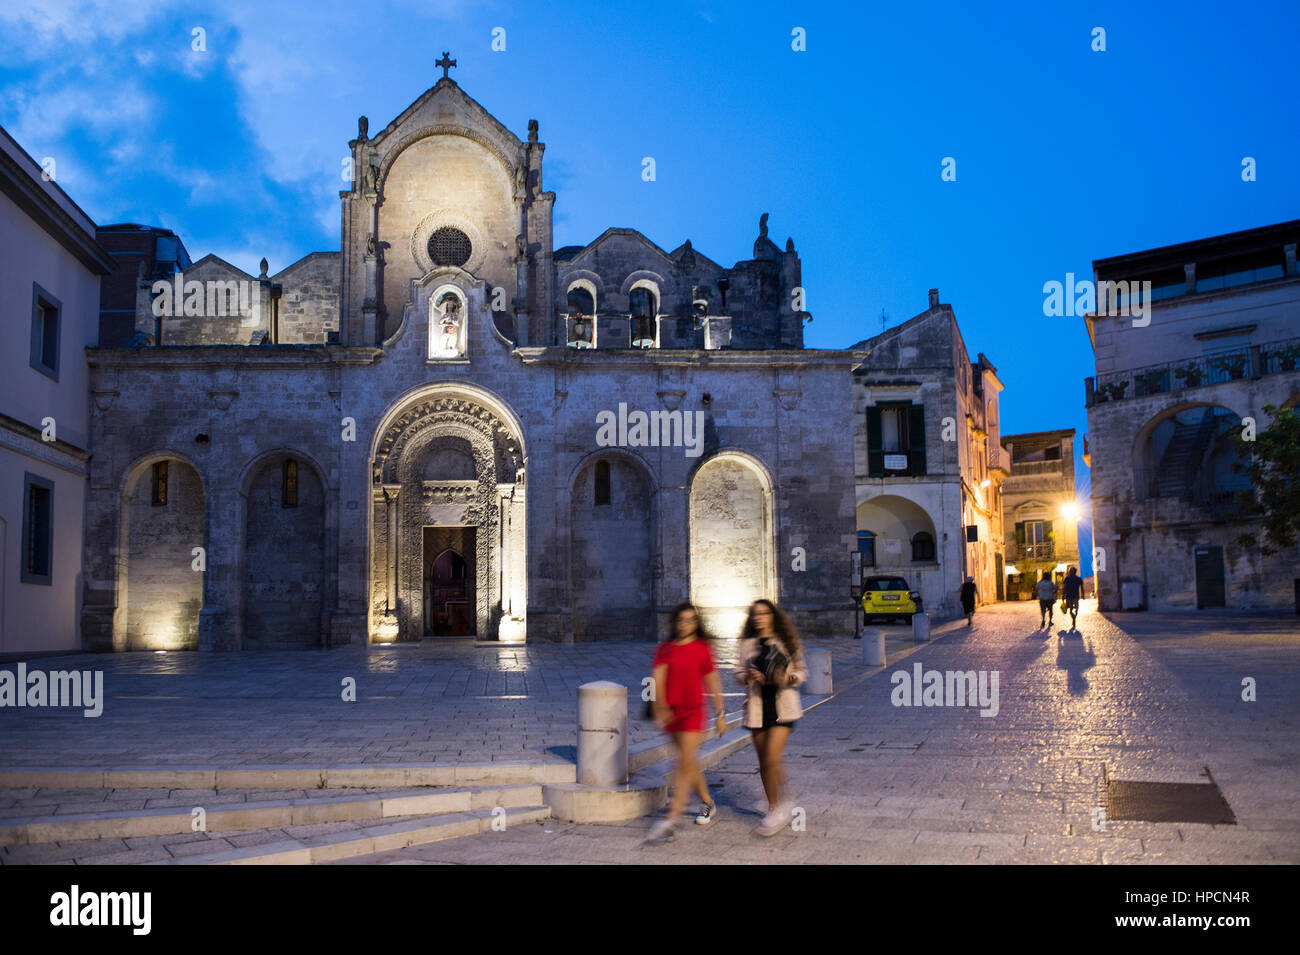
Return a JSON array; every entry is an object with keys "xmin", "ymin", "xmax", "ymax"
[{"xmin": 113, "ymin": 448, "xmax": 208, "ymax": 650}]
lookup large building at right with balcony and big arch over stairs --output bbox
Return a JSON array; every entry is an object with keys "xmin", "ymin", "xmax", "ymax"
[{"xmin": 1086, "ymin": 221, "xmax": 1300, "ymax": 611}]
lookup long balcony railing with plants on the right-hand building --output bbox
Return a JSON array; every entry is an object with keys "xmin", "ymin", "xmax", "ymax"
[{"xmin": 1087, "ymin": 338, "xmax": 1300, "ymax": 408}]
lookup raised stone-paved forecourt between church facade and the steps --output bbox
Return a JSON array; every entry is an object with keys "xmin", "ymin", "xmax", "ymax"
[{"xmin": 0, "ymin": 626, "xmax": 911, "ymax": 767}]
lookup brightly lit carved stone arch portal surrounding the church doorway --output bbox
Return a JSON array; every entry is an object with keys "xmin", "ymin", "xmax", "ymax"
[{"xmin": 368, "ymin": 382, "xmax": 527, "ymax": 642}]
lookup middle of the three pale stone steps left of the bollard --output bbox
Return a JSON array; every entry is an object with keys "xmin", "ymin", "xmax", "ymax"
[{"xmin": 0, "ymin": 783, "xmax": 542, "ymax": 846}]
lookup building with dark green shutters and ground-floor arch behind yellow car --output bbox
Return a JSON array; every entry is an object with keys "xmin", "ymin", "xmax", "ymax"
[{"xmin": 853, "ymin": 290, "xmax": 1011, "ymax": 618}]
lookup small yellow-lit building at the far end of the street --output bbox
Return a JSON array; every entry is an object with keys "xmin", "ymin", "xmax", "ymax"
[{"xmin": 1002, "ymin": 427, "xmax": 1082, "ymax": 600}]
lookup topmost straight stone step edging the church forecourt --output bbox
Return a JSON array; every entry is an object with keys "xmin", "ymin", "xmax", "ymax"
[{"xmin": 0, "ymin": 760, "xmax": 577, "ymax": 790}]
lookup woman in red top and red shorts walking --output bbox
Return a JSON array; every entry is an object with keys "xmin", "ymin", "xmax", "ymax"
[{"xmin": 649, "ymin": 603, "xmax": 727, "ymax": 841}]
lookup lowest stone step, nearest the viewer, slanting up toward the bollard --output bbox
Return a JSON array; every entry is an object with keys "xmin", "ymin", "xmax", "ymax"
[{"xmin": 155, "ymin": 806, "xmax": 551, "ymax": 865}]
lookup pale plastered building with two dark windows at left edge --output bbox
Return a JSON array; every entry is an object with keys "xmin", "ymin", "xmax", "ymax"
[{"xmin": 0, "ymin": 129, "xmax": 113, "ymax": 654}]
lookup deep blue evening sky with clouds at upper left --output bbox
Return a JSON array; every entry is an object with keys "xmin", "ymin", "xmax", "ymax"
[{"xmin": 0, "ymin": 0, "xmax": 1300, "ymax": 574}]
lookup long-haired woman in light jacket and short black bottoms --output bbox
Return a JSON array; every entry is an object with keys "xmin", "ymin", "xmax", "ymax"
[{"xmin": 736, "ymin": 600, "xmax": 807, "ymax": 835}]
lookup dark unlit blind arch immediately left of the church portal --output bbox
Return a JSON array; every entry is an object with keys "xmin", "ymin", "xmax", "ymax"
[{"xmin": 235, "ymin": 447, "xmax": 338, "ymax": 648}]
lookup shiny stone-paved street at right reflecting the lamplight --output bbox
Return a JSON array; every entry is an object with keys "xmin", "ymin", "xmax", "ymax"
[{"xmin": 340, "ymin": 602, "xmax": 1300, "ymax": 864}]
